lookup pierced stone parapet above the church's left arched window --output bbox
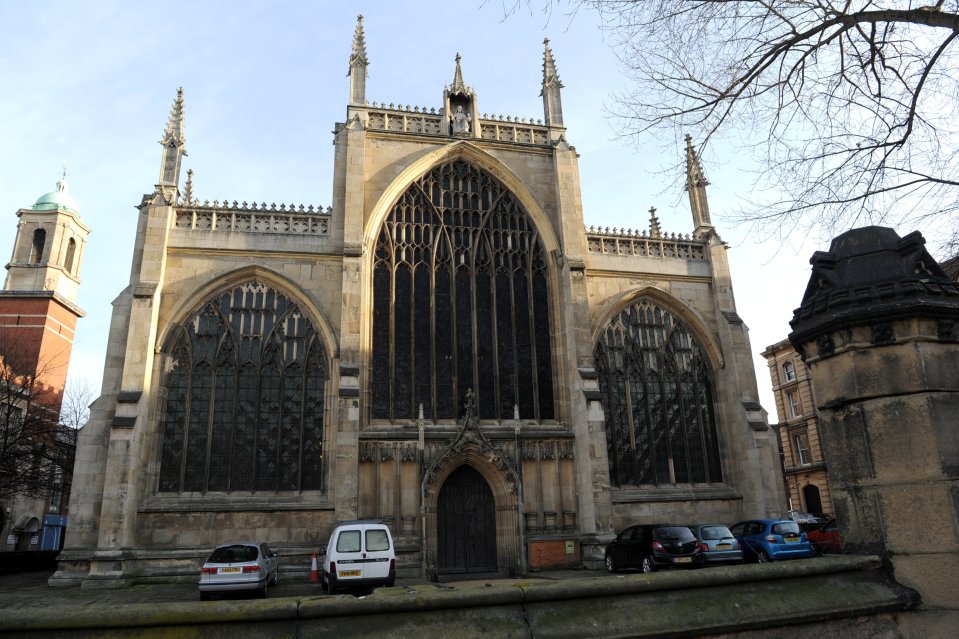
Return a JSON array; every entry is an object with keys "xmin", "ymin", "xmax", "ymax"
[{"xmin": 173, "ymin": 200, "xmax": 333, "ymax": 235}]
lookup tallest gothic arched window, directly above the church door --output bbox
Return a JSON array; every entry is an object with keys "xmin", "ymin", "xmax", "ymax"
[{"xmin": 371, "ymin": 160, "xmax": 554, "ymax": 420}]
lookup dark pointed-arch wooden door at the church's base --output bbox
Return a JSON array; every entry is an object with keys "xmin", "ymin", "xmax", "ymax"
[{"xmin": 436, "ymin": 465, "xmax": 497, "ymax": 574}]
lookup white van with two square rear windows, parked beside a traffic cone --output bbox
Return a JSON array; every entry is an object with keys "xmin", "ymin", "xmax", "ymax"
[{"xmin": 320, "ymin": 519, "xmax": 396, "ymax": 595}]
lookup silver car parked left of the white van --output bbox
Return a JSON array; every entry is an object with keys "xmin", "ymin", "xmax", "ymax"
[{"xmin": 199, "ymin": 541, "xmax": 280, "ymax": 601}]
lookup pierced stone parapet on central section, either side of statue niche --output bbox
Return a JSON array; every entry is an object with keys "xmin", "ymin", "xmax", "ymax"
[{"xmin": 366, "ymin": 102, "xmax": 549, "ymax": 145}]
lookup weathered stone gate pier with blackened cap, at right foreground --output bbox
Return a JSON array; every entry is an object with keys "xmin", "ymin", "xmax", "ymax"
[{"xmin": 789, "ymin": 227, "xmax": 959, "ymax": 637}]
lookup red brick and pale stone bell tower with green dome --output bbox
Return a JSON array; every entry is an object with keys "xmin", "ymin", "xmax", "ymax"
[{"xmin": 0, "ymin": 169, "xmax": 90, "ymax": 396}]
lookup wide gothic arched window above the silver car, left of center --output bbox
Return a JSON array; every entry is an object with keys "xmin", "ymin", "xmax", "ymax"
[{"xmin": 159, "ymin": 282, "xmax": 328, "ymax": 492}]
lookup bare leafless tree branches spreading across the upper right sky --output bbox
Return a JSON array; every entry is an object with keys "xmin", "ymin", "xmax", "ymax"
[{"xmin": 556, "ymin": 0, "xmax": 959, "ymax": 252}]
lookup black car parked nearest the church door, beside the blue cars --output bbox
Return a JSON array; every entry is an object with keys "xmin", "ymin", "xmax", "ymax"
[{"xmin": 606, "ymin": 524, "xmax": 704, "ymax": 572}]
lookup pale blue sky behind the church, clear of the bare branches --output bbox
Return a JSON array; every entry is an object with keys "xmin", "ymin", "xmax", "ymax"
[{"xmin": 0, "ymin": 0, "xmax": 856, "ymax": 422}]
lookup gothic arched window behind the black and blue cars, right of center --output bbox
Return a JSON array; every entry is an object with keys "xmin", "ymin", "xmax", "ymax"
[{"xmin": 593, "ymin": 299, "xmax": 722, "ymax": 486}]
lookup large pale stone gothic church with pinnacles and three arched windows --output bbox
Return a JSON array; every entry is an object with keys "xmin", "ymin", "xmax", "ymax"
[{"xmin": 51, "ymin": 17, "xmax": 783, "ymax": 587}]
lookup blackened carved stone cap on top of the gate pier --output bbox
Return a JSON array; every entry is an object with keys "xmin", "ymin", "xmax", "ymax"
[{"xmin": 789, "ymin": 226, "xmax": 959, "ymax": 355}]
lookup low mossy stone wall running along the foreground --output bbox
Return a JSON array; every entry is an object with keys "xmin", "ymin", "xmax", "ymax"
[{"xmin": 0, "ymin": 557, "xmax": 924, "ymax": 639}]
